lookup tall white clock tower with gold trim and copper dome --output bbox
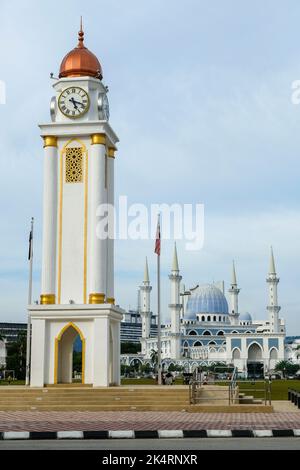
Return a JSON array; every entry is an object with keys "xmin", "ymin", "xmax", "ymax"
[{"xmin": 29, "ymin": 23, "xmax": 123, "ymax": 387}]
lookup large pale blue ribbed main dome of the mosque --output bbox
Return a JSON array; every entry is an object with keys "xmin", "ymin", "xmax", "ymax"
[{"xmin": 184, "ymin": 284, "xmax": 228, "ymax": 320}]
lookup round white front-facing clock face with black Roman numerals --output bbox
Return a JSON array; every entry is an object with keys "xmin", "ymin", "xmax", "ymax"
[{"xmin": 58, "ymin": 87, "xmax": 90, "ymax": 118}]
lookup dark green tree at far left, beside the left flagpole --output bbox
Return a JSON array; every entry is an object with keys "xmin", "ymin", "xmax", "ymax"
[{"xmin": 6, "ymin": 331, "xmax": 27, "ymax": 380}]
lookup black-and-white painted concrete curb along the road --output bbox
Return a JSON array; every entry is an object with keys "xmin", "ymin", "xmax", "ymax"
[{"xmin": 0, "ymin": 429, "xmax": 300, "ymax": 441}]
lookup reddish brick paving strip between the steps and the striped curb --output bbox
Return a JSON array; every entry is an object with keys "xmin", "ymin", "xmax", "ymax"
[{"xmin": 0, "ymin": 411, "xmax": 300, "ymax": 431}]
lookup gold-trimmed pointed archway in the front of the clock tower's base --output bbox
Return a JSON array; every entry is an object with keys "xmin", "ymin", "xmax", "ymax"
[{"xmin": 54, "ymin": 322, "xmax": 85, "ymax": 384}]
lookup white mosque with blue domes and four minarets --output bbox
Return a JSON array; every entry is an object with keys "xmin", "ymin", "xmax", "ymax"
[{"xmin": 131, "ymin": 245, "xmax": 288, "ymax": 377}]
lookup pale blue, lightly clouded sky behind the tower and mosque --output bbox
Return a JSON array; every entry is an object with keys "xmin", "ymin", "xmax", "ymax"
[{"xmin": 0, "ymin": 0, "xmax": 300, "ymax": 335}]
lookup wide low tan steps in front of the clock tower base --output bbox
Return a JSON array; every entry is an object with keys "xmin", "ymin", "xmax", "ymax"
[{"xmin": 0, "ymin": 385, "xmax": 190, "ymax": 411}]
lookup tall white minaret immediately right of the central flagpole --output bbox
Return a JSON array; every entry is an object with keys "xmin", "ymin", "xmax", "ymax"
[{"xmin": 169, "ymin": 243, "xmax": 182, "ymax": 358}]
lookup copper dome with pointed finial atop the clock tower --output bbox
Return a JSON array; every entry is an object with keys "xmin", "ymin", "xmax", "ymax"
[{"xmin": 59, "ymin": 22, "xmax": 103, "ymax": 80}]
